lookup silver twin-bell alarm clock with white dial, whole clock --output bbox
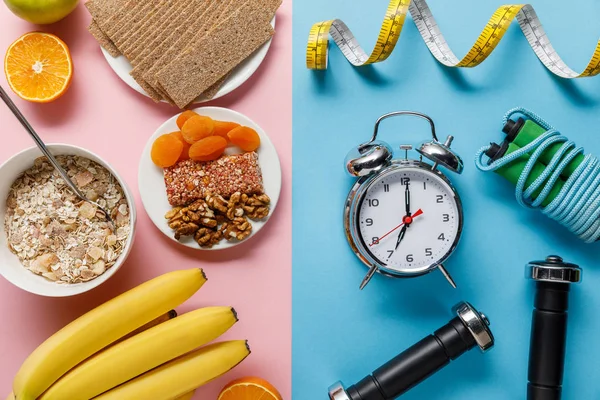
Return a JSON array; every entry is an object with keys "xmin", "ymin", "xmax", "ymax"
[{"xmin": 344, "ymin": 111, "xmax": 463, "ymax": 289}]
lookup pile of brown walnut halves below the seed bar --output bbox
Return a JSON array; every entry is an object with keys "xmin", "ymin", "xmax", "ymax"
[{"xmin": 165, "ymin": 192, "xmax": 271, "ymax": 247}]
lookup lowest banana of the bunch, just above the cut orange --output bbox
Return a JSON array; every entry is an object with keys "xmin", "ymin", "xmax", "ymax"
[{"xmin": 94, "ymin": 340, "xmax": 250, "ymax": 400}]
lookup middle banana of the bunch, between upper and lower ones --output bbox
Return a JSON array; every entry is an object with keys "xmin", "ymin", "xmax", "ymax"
[{"xmin": 38, "ymin": 307, "xmax": 237, "ymax": 400}]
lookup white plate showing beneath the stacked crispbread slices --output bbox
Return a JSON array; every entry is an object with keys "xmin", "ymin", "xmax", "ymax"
[{"xmin": 100, "ymin": 17, "xmax": 275, "ymax": 103}]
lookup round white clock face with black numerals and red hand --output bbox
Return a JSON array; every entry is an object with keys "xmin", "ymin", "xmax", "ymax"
[{"xmin": 355, "ymin": 167, "xmax": 462, "ymax": 274}]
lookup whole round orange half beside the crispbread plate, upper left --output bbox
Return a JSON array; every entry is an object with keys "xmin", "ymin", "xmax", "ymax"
[{"xmin": 4, "ymin": 32, "xmax": 73, "ymax": 103}]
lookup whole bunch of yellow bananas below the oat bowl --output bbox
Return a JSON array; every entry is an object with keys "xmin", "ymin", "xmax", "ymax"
[{"xmin": 8, "ymin": 269, "xmax": 250, "ymax": 400}]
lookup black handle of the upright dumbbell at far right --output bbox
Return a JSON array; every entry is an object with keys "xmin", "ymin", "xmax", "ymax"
[{"xmin": 527, "ymin": 282, "xmax": 570, "ymax": 400}]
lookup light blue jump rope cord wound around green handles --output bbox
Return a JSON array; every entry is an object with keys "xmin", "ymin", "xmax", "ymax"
[{"xmin": 475, "ymin": 107, "xmax": 600, "ymax": 243}]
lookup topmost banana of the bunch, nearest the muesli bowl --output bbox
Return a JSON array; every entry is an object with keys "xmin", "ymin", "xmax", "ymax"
[{"xmin": 13, "ymin": 268, "xmax": 206, "ymax": 400}]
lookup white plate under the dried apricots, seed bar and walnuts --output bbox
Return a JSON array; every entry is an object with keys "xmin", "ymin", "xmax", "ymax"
[{"xmin": 138, "ymin": 107, "xmax": 281, "ymax": 250}]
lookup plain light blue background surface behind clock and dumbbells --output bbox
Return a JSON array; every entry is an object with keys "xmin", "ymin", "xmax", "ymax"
[{"xmin": 293, "ymin": 0, "xmax": 600, "ymax": 400}]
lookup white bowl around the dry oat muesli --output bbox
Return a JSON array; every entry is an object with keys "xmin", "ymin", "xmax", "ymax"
[{"xmin": 0, "ymin": 144, "xmax": 136, "ymax": 297}]
